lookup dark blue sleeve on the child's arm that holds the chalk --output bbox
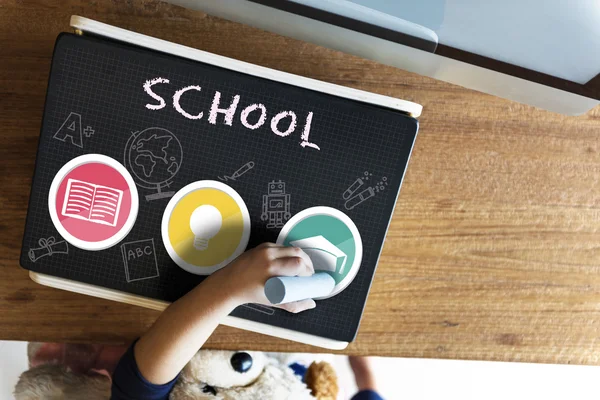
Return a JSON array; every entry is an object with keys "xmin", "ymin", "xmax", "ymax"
[{"xmin": 110, "ymin": 340, "xmax": 177, "ymax": 400}]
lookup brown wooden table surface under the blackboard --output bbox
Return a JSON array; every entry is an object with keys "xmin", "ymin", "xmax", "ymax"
[{"xmin": 0, "ymin": 0, "xmax": 600, "ymax": 364}]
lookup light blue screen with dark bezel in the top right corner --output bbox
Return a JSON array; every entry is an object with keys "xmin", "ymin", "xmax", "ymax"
[{"xmin": 251, "ymin": 0, "xmax": 600, "ymax": 99}]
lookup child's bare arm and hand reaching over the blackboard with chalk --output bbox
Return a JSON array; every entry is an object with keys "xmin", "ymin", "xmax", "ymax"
[{"xmin": 134, "ymin": 243, "xmax": 315, "ymax": 385}]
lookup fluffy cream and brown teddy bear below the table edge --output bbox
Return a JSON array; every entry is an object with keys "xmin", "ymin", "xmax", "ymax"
[{"xmin": 14, "ymin": 348, "xmax": 338, "ymax": 400}]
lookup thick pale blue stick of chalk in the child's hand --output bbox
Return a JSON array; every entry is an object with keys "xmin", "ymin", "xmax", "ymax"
[{"xmin": 265, "ymin": 272, "xmax": 335, "ymax": 304}]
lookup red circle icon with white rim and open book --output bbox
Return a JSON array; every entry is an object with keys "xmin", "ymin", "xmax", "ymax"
[{"xmin": 48, "ymin": 154, "xmax": 138, "ymax": 250}]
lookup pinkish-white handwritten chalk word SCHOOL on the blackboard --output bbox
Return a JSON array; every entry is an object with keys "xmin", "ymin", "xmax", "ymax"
[{"xmin": 144, "ymin": 77, "xmax": 321, "ymax": 150}]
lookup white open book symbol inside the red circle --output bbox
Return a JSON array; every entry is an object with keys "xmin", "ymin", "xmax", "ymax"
[{"xmin": 62, "ymin": 179, "xmax": 123, "ymax": 226}]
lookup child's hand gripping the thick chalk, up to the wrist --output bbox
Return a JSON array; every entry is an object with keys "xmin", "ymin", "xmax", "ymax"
[{"xmin": 207, "ymin": 243, "xmax": 316, "ymax": 313}]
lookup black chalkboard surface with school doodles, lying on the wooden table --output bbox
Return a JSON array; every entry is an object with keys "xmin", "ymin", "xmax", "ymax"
[{"xmin": 21, "ymin": 34, "xmax": 418, "ymax": 341}]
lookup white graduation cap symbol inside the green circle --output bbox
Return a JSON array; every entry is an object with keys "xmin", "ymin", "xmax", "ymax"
[{"xmin": 290, "ymin": 235, "xmax": 348, "ymax": 274}]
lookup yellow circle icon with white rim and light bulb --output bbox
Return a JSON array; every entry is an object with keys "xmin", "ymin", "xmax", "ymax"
[{"xmin": 162, "ymin": 181, "xmax": 250, "ymax": 275}]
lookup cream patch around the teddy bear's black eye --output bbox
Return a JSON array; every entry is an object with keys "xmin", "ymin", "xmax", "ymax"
[{"xmin": 179, "ymin": 350, "xmax": 267, "ymax": 391}]
